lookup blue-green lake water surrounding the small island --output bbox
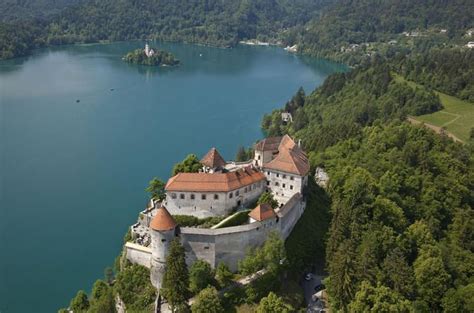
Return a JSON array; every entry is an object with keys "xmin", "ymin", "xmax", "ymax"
[{"xmin": 0, "ymin": 42, "xmax": 345, "ymax": 313}]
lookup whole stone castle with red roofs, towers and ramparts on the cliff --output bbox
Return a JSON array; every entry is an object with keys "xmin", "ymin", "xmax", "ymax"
[{"xmin": 124, "ymin": 135, "xmax": 309, "ymax": 290}]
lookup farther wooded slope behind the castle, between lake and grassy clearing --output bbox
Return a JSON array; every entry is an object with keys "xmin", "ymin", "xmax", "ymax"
[{"xmin": 262, "ymin": 60, "xmax": 441, "ymax": 150}]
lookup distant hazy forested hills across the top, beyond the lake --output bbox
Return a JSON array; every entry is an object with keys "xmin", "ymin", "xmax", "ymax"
[{"xmin": 0, "ymin": 0, "xmax": 474, "ymax": 64}]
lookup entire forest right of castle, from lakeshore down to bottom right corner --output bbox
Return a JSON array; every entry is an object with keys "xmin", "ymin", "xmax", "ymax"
[{"xmin": 262, "ymin": 56, "xmax": 474, "ymax": 312}]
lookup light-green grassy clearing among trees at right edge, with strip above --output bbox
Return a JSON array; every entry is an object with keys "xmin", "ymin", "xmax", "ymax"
[{"xmin": 395, "ymin": 75, "xmax": 474, "ymax": 141}]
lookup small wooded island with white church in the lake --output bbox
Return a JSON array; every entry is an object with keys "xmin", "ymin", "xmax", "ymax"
[{"xmin": 122, "ymin": 44, "xmax": 179, "ymax": 66}]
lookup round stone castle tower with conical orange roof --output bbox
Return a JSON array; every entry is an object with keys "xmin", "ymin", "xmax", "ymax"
[{"xmin": 150, "ymin": 206, "xmax": 177, "ymax": 291}]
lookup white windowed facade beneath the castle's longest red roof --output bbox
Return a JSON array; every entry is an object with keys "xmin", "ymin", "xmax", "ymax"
[{"xmin": 164, "ymin": 181, "xmax": 265, "ymax": 218}]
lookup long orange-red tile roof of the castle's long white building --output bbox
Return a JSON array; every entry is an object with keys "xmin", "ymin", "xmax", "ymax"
[{"xmin": 165, "ymin": 167, "xmax": 265, "ymax": 192}]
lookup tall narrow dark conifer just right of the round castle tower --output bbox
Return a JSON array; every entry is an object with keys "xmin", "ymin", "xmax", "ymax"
[{"xmin": 161, "ymin": 238, "xmax": 189, "ymax": 312}]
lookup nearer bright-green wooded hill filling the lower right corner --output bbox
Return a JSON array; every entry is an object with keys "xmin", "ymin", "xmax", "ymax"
[{"xmin": 320, "ymin": 123, "xmax": 474, "ymax": 312}]
